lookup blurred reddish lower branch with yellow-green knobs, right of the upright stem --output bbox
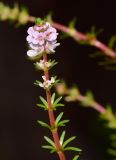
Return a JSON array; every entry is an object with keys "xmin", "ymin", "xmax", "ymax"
[{"xmin": 56, "ymin": 83, "xmax": 116, "ymax": 129}]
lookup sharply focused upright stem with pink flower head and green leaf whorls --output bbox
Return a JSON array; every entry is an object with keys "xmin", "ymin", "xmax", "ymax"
[{"xmin": 27, "ymin": 19, "xmax": 81, "ymax": 160}]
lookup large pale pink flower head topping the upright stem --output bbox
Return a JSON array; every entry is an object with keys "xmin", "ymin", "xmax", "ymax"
[{"xmin": 27, "ymin": 22, "xmax": 60, "ymax": 58}]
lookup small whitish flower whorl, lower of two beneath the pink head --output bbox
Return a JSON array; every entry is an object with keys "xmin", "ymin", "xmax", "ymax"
[{"xmin": 39, "ymin": 76, "xmax": 55, "ymax": 89}]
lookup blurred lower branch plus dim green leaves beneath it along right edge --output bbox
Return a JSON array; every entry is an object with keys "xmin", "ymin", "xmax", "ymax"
[{"xmin": 56, "ymin": 82, "xmax": 116, "ymax": 157}]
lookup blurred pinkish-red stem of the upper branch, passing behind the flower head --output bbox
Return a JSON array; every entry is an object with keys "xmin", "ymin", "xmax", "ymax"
[{"xmin": 29, "ymin": 16, "xmax": 116, "ymax": 59}]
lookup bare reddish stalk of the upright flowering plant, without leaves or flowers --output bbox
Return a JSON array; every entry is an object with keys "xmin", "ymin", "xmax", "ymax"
[{"xmin": 43, "ymin": 53, "xmax": 66, "ymax": 160}]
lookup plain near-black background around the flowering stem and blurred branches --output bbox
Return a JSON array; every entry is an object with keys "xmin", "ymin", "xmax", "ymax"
[{"xmin": 0, "ymin": 0, "xmax": 116, "ymax": 160}]
